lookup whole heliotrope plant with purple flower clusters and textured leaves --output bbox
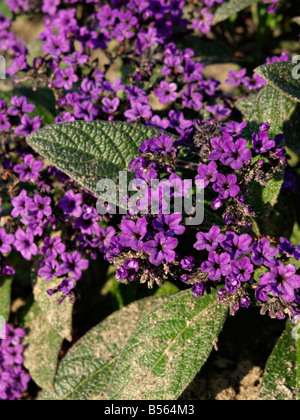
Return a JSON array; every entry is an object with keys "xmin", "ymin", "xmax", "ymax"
[{"xmin": 0, "ymin": 0, "xmax": 300, "ymax": 400}]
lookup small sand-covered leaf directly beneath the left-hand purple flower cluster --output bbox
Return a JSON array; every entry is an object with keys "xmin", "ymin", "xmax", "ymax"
[{"xmin": 33, "ymin": 277, "xmax": 73, "ymax": 341}]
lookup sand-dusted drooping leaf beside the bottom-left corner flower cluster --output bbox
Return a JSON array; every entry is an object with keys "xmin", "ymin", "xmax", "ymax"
[{"xmin": 24, "ymin": 302, "xmax": 63, "ymax": 390}]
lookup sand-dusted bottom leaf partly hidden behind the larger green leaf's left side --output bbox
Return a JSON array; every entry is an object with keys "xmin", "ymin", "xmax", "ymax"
[{"xmin": 40, "ymin": 297, "xmax": 163, "ymax": 400}]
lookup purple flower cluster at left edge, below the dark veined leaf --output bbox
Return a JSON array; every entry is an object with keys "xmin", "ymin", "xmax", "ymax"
[{"xmin": 0, "ymin": 166, "xmax": 115, "ymax": 303}]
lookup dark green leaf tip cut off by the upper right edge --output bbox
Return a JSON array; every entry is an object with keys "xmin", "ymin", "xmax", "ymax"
[{"xmin": 255, "ymin": 62, "xmax": 300, "ymax": 102}]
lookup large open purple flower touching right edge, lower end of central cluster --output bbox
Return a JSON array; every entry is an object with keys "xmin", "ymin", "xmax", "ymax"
[{"xmin": 259, "ymin": 261, "xmax": 300, "ymax": 302}]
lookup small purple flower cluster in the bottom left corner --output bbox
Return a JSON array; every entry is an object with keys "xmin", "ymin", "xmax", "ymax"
[{"xmin": 0, "ymin": 324, "xmax": 30, "ymax": 401}]
